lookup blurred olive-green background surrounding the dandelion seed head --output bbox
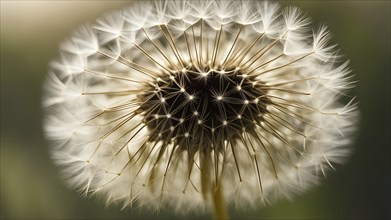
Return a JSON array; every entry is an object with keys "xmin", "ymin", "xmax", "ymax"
[{"xmin": 0, "ymin": 0, "xmax": 391, "ymax": 219}]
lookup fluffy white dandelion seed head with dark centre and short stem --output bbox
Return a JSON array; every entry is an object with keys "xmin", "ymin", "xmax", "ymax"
[{"xmin": 43, "ymin": 0, "xmax": 358, "ymax": 218}]
